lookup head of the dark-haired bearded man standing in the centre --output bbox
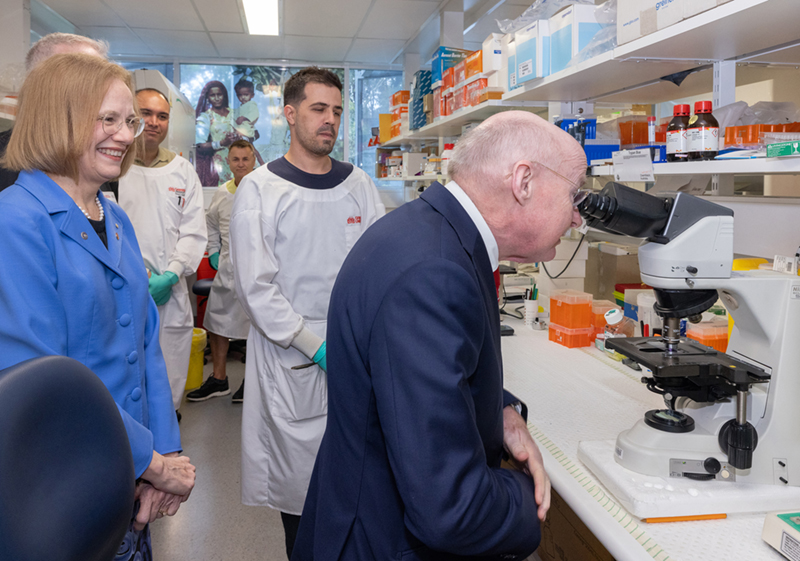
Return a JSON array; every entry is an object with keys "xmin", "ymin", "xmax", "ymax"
[{"xmin": 283, "ymin": 66, "xmax": 343, "ymax": 156}]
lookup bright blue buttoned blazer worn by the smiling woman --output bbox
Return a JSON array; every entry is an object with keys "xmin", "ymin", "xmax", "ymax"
[{"xmin": 0, "ymin": 171, "xmax": 181, "ymax": 477}]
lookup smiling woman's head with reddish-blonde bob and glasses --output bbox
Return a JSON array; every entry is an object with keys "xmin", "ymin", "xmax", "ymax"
[{"xmin": 3, "ymin": 54, "xmax": 143, "ymax": 188}]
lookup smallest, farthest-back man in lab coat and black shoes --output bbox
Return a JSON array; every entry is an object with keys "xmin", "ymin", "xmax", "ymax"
[{"xmin": 186, "ymin": 140, "xmax": 256, "ymax": 403}]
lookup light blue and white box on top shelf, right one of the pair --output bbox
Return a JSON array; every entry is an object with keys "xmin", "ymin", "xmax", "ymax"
[{"xmin": 550, "ymin": 4, "xmax": 601, "ymax": 74}]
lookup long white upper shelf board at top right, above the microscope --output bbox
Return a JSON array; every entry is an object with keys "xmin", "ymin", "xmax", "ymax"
[{"xmin": 503, "ymin": 0, "xmax": 800, "ymax": 103}]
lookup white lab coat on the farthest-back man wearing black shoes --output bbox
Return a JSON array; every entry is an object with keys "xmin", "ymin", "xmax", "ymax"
[{"xmin": 203, "ymin": 179, "xmax": 250, "ymax": 339}]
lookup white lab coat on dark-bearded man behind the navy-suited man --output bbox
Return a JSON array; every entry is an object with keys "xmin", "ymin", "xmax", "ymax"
[{"xmin": 231, "ymin": 162, "xmax": 385, "ymax": 515}]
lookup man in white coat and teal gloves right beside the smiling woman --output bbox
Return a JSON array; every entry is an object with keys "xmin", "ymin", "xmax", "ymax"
[{"xmin": 119, "ymin": 89, "xmax": 207, "ymax": 420}]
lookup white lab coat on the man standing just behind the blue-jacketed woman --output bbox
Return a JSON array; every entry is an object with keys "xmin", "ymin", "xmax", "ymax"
[{"xmin": 119, "ymin": 156, "xmax": 208, "ymax": 409}]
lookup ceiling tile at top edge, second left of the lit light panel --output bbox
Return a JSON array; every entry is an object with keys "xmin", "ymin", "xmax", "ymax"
[{"xmin": 103, "ymin": 0, "xmax": 203, "ymax": 31}]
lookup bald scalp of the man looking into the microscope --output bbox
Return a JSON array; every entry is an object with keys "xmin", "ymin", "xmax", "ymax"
[{"xmin": 448, "ymin": 111, "xmax": 586, "ymax": 187}]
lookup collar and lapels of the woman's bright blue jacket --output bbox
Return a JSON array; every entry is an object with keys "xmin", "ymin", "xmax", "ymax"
[{"xmin": 17, "ymin": 170, "xmax": 122, "ymax": 276}]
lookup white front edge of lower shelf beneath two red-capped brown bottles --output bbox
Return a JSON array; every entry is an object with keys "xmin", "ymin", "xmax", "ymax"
[{"xmin": 592, "ymin": 158, "xmax": 800, "ymax": 176}]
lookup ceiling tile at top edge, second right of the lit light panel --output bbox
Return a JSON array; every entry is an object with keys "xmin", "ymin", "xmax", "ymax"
[{"xmin": 358, "ymin": 0, "xmax": 438, "ymax": 40}]
